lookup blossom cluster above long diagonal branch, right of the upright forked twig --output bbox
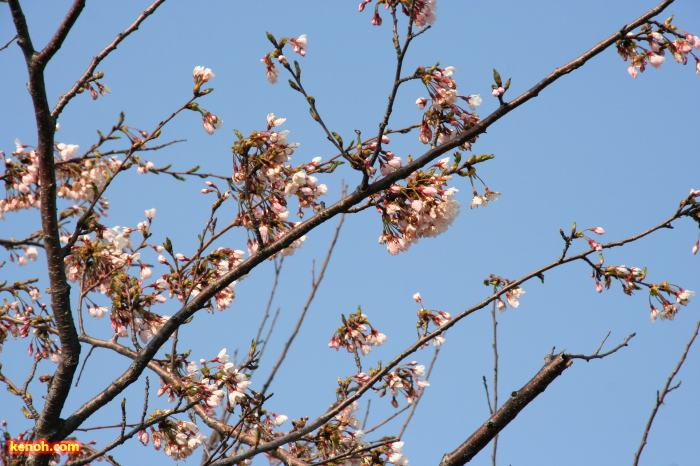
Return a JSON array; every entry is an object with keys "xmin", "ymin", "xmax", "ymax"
[{"xmin": 416, "ymin": 65, "xmax": 482, "ymax": 149}]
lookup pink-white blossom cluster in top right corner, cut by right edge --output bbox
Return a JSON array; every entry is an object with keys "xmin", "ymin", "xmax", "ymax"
[{"xmin": 617, "ymin": 18, "xmax": 700, "ymax": 78}]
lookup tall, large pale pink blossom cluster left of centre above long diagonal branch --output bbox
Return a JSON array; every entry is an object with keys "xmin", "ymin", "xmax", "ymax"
[{"xmin": 228, "ymin": 113, "xmax": 335, "ymax": 255}]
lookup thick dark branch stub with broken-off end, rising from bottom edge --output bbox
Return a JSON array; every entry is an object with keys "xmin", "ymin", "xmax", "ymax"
[{"xmin": 440, "ymin": 354, "xmax": 573, "ymax": 466}]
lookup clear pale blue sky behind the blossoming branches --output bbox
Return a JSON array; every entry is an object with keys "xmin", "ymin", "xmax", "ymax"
[{"xmin": 0, "ymin": 0, "xmax": 700, "ymax": 466}]
